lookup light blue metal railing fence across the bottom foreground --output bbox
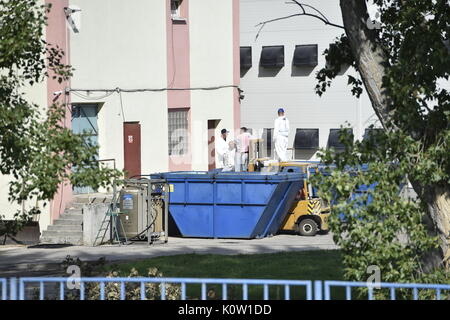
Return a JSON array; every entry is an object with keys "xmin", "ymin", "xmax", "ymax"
[{"xmin": 0, "ymin": 277, "xmax": 450, "ymax": 300}]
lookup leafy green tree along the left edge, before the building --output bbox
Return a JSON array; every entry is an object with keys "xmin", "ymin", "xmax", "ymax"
[{"xmin": 0, "ymin": 0, "xmax": 120, "ymax": 225}]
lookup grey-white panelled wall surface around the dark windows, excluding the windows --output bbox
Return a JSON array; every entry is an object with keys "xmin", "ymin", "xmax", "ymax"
[{"xmin": 240, "ymin": 0, "xmax": 376, "ymax": 159}]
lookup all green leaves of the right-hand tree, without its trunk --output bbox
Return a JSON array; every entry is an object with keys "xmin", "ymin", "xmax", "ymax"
[{"xmin": 313, "ymin": 0, "xmax": 450, "ymax": 284}]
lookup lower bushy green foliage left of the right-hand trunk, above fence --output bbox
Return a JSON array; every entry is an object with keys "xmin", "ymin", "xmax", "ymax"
[{"xmin": 312, "ymin": 130, "xmax": 442, "ymax": 282}]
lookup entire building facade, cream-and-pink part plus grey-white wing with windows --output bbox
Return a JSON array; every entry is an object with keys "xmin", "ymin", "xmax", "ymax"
[{"xmin": 0, "ymin": 0, "xmax": 384, "ymax": 235}]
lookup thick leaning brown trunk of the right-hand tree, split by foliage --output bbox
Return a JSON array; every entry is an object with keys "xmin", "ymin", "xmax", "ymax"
[{"xmin": 340, "ymin": 0, "xmax": 450, "ymax": 271}]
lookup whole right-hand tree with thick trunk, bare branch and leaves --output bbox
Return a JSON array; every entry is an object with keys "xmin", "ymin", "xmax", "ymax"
[{"xmin": 262, "ymin": 0, "xmax": 450, "ymax": 281}]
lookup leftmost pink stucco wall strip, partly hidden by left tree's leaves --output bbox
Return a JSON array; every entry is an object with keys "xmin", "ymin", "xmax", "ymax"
[{"xmin": 45, "ymin": 0, "xmax": 72, "ymax": 223}]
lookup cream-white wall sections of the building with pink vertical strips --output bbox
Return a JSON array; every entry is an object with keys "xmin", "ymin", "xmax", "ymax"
[{"xmin": 70, "ymin": 0, "xmax": 235, "ymax": 173}]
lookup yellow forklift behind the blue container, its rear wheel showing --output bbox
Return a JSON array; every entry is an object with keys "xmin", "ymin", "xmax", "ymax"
[{"xmin": 248, "ymin": 141, "xmax": 330, "ymax": 236}]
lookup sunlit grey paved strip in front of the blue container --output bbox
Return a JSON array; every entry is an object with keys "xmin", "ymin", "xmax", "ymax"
[{"xmin": 0, "ymin": 234, "xmax": 337, "ymax": 271}]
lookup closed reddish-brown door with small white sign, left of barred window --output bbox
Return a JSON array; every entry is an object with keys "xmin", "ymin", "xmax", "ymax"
[{"xmin": 123, "ymin": 122, "xmax": 141, "ymax": 178}]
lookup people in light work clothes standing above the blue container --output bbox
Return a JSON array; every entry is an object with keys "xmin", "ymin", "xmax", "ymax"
[{"xmin": 216, "ymin": 108, "xmax": 289, "ymax": 172}]
